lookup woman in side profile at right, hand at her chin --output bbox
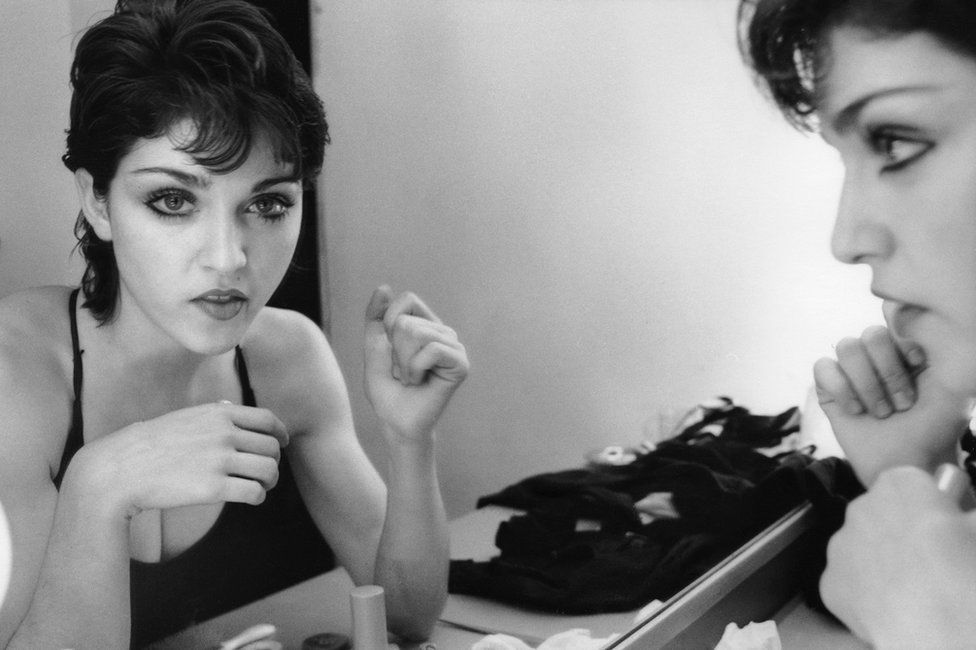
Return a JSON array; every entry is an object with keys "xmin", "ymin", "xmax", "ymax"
[{"xmin": 740, "ymin": 0, "xmax": 976, "ymax": 648}]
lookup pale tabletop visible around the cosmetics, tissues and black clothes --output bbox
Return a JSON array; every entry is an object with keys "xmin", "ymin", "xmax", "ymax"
[{"xmin": 145, "ymin": 506, "xmax": 867, "ymax": 650}]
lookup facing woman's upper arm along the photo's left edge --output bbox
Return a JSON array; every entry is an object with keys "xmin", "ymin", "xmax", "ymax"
[{"xmin": 0, "ymin": 328, "xmax": 70, "ymax": 647}]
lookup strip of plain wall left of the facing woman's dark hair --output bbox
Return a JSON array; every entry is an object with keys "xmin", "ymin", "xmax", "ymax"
[{"xmin": 0, "ymin": 0, "xmax": 93, "ymax": 295}]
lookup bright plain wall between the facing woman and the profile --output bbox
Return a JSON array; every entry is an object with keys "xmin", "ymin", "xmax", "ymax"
[{"xmin": 313, "ymin": 0, "xmax": 880, "ymax": 514}]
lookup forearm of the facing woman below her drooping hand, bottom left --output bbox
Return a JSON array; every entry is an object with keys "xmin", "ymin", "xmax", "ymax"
[{"xmin": 7, "ymin": 470, "xmax": 130, "ymax": 650}]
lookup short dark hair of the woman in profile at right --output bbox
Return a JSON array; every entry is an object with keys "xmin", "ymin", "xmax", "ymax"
[{"xmin": 738, "ymin": 0, "xmax": 976, "ymax": 131}]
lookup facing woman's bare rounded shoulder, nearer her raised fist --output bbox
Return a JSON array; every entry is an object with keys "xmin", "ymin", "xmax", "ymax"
[{"xmin": 242, "ymin": 307, "xmax": 349, "ymax": 431}]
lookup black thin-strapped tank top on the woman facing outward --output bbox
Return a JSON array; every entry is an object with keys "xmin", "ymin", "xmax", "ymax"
[{"xmin": 54, "ymin": 289, "xmax": 335, "ymax": 648}]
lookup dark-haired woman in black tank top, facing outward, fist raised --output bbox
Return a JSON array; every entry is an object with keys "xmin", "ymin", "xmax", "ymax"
[{"xmin": 0, "ymin": 0, "xmax": 468, "ymax": 648}]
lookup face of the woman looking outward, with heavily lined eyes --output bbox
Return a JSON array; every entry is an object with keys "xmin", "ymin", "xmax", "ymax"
[{"xmin": 93, "ymin": 123, "xmax": 302, "ymax": 354}]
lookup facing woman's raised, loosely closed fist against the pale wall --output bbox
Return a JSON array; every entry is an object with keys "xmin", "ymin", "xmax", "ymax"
[{"xmin": 365, "ymin": 286, "xmax": 469, "ymax": 440}]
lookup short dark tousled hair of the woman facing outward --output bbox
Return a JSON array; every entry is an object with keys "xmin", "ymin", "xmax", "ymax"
[{"xmin": 62, "ymin": 0, "xmax": 329, "ymax": 323}]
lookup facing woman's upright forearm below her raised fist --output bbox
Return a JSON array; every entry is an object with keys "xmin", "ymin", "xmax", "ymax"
[{"xmin": 374, "ymin": 430, "xmax": 450, "ymax": 639}]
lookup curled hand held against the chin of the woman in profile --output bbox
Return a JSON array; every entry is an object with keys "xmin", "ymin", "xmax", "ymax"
[{"xmin": 814, "ymin": 326, "xmax": 968, "ymax": 486}]
